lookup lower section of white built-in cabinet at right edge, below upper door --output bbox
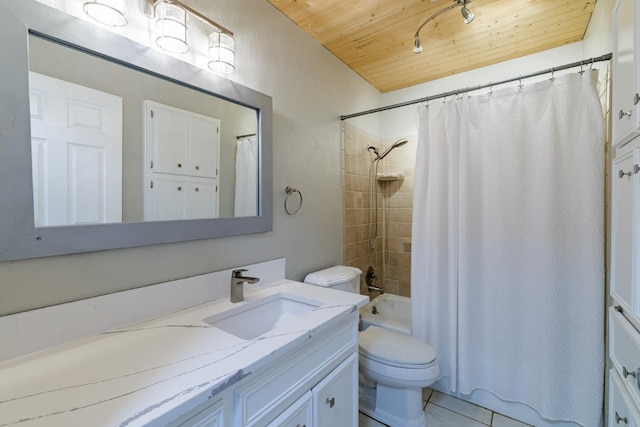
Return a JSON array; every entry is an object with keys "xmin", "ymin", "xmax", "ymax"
[{"xmin": 607, "ymin": 130, "xmax": 640, "ymax": 418}]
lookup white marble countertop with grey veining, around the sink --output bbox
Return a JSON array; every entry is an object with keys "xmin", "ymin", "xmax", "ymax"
[{"xmin": 0, "ymin": 281, "xmax": 367, "ymax": 427}]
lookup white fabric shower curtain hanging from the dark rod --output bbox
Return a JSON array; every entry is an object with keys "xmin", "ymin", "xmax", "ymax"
[{"xmin": 411, "ymin": 70, "xmax": 604, "ymax": 427}]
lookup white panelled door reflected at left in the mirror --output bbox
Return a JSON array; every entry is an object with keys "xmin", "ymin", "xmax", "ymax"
[{"xmin": 29, "ymin": 72, "xmax": 122, "ymax": 226}]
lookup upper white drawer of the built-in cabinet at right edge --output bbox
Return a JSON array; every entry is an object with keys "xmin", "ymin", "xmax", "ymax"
[{"xmin": 609, "ymin": 308, "xmax": 640, "ymax": 407}]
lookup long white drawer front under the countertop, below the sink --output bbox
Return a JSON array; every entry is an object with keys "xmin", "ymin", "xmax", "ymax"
[{"xmin": 234, "ymin": 320, "xmax": 358, "ymax": 426}]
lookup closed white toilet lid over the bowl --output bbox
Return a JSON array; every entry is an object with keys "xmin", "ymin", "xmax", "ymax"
[{"xmin": 358, "ymin": 326, "xmax": 436, "ymax": 368}]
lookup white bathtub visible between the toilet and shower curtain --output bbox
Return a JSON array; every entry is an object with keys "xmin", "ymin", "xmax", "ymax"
[{"xmin": 360, "ymin": 294, "xmax": 411, "ymax": 335}]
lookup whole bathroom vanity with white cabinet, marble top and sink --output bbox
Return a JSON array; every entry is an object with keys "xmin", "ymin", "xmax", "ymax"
[{"xmin": 0, "ymin": 280, "xmax": 367, "ymax": 427}]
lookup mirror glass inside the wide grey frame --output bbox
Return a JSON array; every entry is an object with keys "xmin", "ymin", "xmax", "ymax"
[{"xmin": 29, "ymin": 35, "xmax": 258, "ymax": 227}]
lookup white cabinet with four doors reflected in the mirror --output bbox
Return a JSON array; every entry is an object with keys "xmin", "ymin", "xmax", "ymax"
[{"xmin": 145, "ymin": 101, "xmax": 220, "ymax": 220}]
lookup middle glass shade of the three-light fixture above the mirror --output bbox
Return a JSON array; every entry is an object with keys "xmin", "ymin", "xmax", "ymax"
[{"xmin": 154, "ymin": 0, "xmax": 189, "ymax": 53}]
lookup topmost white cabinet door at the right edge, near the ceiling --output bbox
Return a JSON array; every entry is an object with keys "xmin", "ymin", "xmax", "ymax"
[{"xmin": 611, "ymin": 0, "xmax": 640, "ymax": 145}]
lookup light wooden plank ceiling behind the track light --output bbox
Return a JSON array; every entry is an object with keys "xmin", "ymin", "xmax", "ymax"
[{"xmin": 269, "ymin": 0, "xmax": 596, "ymax": 92}]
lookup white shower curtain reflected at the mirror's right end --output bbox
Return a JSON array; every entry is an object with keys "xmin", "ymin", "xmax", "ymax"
[{"xmin": 233, "ymin": 136, "xmax": 258, "ymax": 217}]
